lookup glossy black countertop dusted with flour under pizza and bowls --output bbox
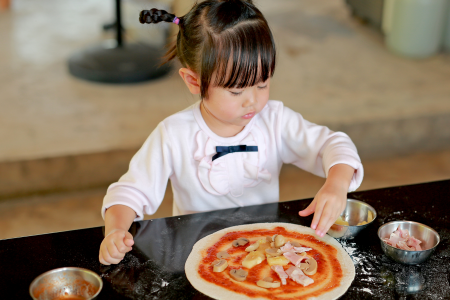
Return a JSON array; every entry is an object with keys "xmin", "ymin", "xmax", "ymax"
[{"xmin": 0, "ymin": 180, "xmax": 450, "ymax": 299}]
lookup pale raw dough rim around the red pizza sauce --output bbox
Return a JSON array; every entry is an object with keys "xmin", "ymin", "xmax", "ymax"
[{"xmin": 184, "ymin": 223, "xmax": 355, "ymax": 300}]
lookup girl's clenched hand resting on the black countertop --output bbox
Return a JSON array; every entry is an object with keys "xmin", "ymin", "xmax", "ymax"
[{"xmin": 99, "ymin": 229, "xmax": 134, "ymax": 265}]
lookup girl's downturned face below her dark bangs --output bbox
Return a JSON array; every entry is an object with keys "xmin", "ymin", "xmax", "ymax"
[{"xmin": 201, "ymin": 78, "xmax": 270, "ymax": 137}]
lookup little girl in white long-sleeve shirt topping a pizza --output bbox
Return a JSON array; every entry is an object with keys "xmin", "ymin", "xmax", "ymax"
[{"xmin": 99, "ymin": 0, "xmax": 363, "ymax": 265}]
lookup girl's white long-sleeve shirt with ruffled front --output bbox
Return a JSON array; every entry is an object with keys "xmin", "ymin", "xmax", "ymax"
[{"xmin": 102, "ymin": 100, "xmax": 364, "ymax": 220}]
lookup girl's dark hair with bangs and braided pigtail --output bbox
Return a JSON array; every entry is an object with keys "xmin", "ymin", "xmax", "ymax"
[{"xmin": 139, "ymin": 0, "xmax": 276, "ymax": 98}]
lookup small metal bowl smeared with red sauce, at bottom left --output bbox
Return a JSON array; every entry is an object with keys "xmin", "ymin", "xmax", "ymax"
[{"xmin": 30, "ymin": 267, "xmax": 103, "ymax": 300}]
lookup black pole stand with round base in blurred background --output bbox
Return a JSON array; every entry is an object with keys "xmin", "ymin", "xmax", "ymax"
[{"xmin": 68, "ymin": 0, "xmax": 170, "ymax": 83}]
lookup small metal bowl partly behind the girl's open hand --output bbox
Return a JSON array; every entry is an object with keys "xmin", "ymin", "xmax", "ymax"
[{"xmin": 327, "ymin": 199, "xmax": 377, "ymax": 240}]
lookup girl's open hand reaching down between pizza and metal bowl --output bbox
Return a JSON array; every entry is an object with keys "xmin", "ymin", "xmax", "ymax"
[{"xmin": 298, "ymin": 164, "xmax": 355, "ymax": 236}]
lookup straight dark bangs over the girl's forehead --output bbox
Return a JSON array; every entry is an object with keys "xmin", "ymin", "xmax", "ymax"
[{"xmin": 200, "ymin": 20, "xmax": 276, "ymax": 98}]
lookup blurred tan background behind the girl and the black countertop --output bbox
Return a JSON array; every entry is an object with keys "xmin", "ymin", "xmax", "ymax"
[{"xmin": 0, "ymin": 0, "xmax": 450, "ymax": 239}]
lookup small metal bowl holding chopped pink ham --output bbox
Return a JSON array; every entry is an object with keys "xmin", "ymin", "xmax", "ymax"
[{"xmin": 378, "ymin": 221, "xmax": 441, "ymax": 265}]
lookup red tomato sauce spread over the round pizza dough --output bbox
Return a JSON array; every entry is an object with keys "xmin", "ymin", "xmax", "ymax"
[{"xmin": 198, "ymin": 227, "xmax": 343, "ymax": 300}]
